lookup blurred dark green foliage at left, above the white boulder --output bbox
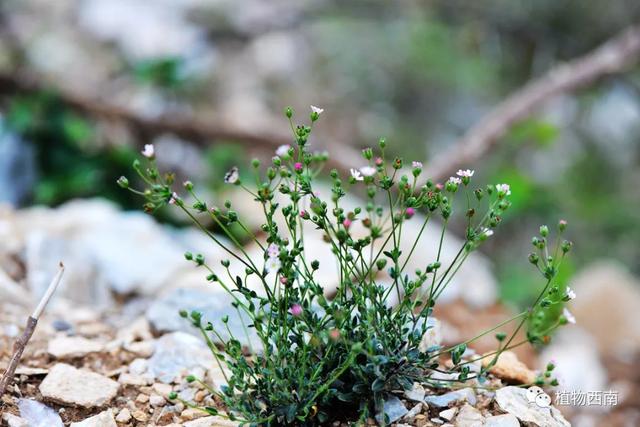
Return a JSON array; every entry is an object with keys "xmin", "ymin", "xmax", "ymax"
[{"xmin": 5, "ymin": 92, "xmax": 135, "ymax": 207}]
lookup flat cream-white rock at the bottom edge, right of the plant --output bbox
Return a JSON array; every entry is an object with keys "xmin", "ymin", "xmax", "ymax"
[{"xmin": 496, "ymin": 386, "xmax": 571, "ymax": 427}]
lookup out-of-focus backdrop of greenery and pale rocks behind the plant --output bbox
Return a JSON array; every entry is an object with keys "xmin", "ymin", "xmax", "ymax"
[{"xmin": 0, "ymin": 0, "xmax": 640, "ymax": 425}]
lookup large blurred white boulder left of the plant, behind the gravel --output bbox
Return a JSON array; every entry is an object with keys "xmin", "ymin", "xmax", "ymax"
[{"xmin": 15, "ymin": 199, "xmax": 208, "ymax": 300}]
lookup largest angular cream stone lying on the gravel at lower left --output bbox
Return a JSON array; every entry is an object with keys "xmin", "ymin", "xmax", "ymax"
[{"xmin": 40, "ymin": 363, "xmax": 120, "ymax": 408}]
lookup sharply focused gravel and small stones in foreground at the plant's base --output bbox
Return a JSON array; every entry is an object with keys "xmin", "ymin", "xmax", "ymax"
[{"xmin": 0, "ymin": 298, "xmax": 569, "ymax": 427}]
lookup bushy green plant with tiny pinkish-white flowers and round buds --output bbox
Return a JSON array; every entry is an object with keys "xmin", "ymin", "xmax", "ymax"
[{"xmin": 118, "ymin": 106, "xmax": 575, "ymax": 425}]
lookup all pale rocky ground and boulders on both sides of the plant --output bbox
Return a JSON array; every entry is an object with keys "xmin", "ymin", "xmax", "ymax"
[{"xmin": 0, "ymin": 201, "xmax": 640, "ymax": 427}]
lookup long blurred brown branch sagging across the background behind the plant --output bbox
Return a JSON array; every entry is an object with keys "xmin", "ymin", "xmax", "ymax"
[{"xmin": 0, "ymin": 25, "xmax": 640, "ymax": 181}]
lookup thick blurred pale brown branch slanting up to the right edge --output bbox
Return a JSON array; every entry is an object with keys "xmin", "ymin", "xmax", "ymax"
[{"xmin": 426, "ymin": 25, "xmax": 640, "ymax": 180}]
